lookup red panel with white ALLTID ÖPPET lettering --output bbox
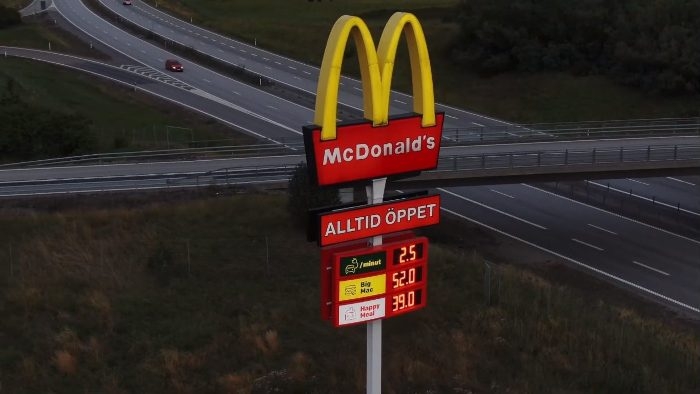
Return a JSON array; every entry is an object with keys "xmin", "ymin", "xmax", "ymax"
[{"xmin": 318, "ymin": 194, "xmax": 440, "ymax": 246}]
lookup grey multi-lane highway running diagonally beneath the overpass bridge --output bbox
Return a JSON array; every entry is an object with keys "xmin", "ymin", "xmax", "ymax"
[{"xmin": 8, "ymin": 0, "xmax": 700, "ymax": 315}]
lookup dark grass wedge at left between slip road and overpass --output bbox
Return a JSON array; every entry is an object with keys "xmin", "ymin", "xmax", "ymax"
[{"xmin": 0, "ymin": 57, "xmax": 253, "ymax": 152}]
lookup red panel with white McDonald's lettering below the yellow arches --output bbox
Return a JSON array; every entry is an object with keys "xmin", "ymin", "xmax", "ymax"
[{"xmin": 304, "ymin": 113, "xmax": 445, "ymax": 186}]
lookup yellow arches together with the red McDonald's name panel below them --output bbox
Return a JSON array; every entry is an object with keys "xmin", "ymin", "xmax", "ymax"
[{"xmin": 304, "ymin": 12, "xmax": 444, "ymax": 186}]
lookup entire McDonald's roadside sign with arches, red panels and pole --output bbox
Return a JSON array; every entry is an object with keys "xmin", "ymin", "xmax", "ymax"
[{"xmin": 303, "ymin": 12, "xmax": 444, "ymax": 394}]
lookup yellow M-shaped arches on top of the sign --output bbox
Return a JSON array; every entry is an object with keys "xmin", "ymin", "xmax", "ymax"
[{"xmin": 314, "ymin": 12, "xmax": 435, "ymax": 140}]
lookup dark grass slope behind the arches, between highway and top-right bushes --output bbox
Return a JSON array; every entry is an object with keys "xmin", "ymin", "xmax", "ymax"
[{"xmin": 149, "ymin": 0, "xmax": 700, "ymax": 123}]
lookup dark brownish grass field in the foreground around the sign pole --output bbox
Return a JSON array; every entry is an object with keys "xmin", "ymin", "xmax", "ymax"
[{"xmin": 0, "ymin": 194, "xmax": 700, "ymax": 394}]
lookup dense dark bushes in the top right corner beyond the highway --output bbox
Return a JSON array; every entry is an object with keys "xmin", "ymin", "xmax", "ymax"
[{"xmin": 451, "ymin": 0, "xmax": 700, "ymax": 93}]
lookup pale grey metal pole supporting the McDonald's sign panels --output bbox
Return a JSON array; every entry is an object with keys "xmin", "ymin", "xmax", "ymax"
[{"xmin": 365, "ymin": 178, "xmax": 386, "ymax": 394}]
